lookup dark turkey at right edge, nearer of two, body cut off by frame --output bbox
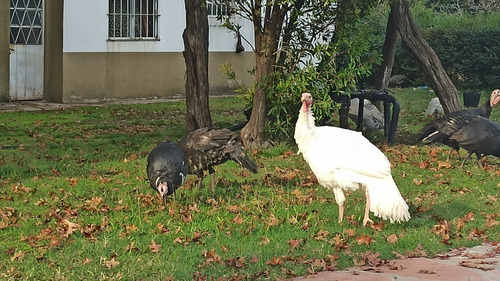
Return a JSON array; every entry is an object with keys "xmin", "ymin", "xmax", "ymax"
[{"xmin": 422, "ymin": 115, "xmax": 500, "ymax": 168}]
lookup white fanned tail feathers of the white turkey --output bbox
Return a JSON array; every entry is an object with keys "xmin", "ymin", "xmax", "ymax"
[{"xmin": 365, "ymin": 177, "xmax": 410, "ymax": 223}]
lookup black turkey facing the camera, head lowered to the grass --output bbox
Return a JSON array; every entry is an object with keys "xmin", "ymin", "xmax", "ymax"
[{"xmin": 147, "ymin": 141, "xmax": 188, "ymax": 200}]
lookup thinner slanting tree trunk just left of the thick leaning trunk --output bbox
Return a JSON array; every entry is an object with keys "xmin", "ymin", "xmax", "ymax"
[{"xmin": 375, "ymin": 1, "xmax": 398, "ymax": 90}]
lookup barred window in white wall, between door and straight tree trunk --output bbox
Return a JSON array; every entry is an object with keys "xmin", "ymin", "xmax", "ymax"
[{"xmin": 108, "ymin": 0, "xmax": 159, "ymax": 40}]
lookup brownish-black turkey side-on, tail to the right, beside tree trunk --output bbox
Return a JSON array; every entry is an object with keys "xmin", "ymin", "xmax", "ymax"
[{"xmin": 179, "ymin": 127, "xmax": 257, "ymax": 189}]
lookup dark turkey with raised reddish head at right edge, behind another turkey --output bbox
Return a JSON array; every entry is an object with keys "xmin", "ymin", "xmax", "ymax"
[{"xmin": 418, "ymin": 89, "xmax": 500, "ymax": 161}]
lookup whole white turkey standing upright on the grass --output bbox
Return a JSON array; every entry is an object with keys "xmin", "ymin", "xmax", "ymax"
[{"xmin": 294, "ymin": 93, "xmax": 410, "ymax": 225}]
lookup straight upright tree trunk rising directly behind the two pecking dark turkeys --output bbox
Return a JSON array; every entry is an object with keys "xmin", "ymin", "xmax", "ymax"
[{"xmin": 182, "ymin": 0, "xmax": 212, "ymax": 133}]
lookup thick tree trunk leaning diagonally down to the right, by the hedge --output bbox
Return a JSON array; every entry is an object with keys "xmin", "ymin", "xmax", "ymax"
[{"xmin": 393, "ymin": 0, "xmax": 462, "ymax": 114}]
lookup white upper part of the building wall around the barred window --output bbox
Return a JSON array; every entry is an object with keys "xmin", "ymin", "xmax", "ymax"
[{"xmin": 63, "ymin": 0, "xmax": 254, "ymax": 53}]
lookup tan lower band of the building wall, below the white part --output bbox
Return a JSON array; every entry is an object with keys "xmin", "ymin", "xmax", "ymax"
[{"xmin": 63, "ymin": 52, "xmax": 255, "ymax": 103}]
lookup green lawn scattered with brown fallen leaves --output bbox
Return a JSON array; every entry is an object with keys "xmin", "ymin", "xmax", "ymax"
[{"xmin": 0, "ymin": 89, "xmax": 500, "ymax": 280}]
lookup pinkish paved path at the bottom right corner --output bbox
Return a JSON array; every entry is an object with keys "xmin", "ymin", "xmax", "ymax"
[{"xmin": 293, "ymin": 244, "xmax": 500, "ymax": 281}]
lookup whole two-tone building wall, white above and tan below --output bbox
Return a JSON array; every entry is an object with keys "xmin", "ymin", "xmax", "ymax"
[{"xmin": 61, "ymin": 0, "xmax": 255, "ymax": 103}]
